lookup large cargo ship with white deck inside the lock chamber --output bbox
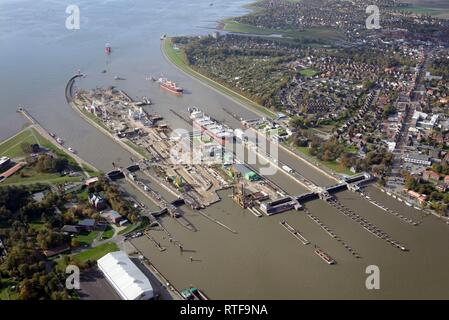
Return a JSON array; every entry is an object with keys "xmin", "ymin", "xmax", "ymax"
[{"xmin": 188, "ymin": 107, "xmax": 234, "ymax": 145}]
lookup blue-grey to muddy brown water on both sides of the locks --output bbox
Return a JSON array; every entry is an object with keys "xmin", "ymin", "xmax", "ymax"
[{"xmin": 0, "ymin": 0, "xmax": 449, "ymax": 299}]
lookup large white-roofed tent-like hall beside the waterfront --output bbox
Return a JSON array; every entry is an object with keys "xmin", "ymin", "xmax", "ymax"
[{"xmin": 97, "ymin": 251, "xmax": 154, "ymax": 300}]
